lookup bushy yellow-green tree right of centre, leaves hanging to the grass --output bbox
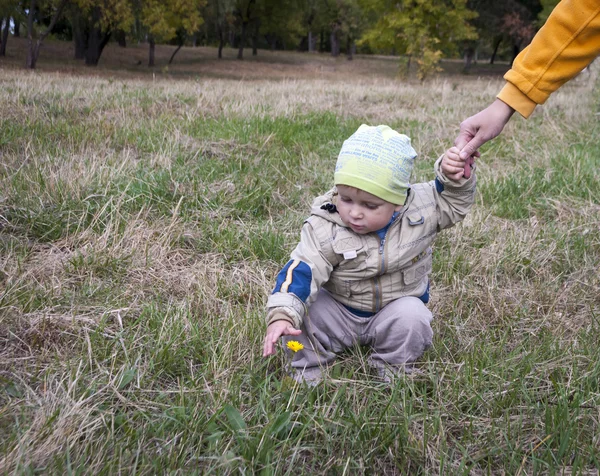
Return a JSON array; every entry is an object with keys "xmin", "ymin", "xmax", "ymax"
[{"xmin": 360, "ymin": 0, "xmax": 477, "ymax": 79}]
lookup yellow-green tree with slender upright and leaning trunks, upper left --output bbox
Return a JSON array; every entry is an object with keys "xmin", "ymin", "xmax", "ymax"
[{"xmin": 141, "ymin": 0, "xmax": 205, "ymax": 66}]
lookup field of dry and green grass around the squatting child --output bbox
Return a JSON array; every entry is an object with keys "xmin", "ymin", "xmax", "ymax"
[{"xmin": 0, "ymin": 38, "xmax": 600, "ymax": 474}]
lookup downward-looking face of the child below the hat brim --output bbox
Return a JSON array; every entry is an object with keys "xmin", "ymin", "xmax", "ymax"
[{"xmin": 336, "ymin": 185, "xmax": 402, "ymax": 235}]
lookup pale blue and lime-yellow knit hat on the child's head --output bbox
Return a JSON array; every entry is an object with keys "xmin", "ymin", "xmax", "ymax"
[{"xmin": 334, "ymin": 124, "xmax": 417, "ymax": 205}]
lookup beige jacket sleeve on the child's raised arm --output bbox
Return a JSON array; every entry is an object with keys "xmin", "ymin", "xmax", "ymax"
[{"xmin": 430, "ymin": 157, "xmax": 476, "ymax": 231}]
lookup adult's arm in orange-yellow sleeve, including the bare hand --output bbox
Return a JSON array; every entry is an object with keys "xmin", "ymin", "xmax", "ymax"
[{"xmin": 454, "ymin": 0, "xmax": 600, "ymax": 158}]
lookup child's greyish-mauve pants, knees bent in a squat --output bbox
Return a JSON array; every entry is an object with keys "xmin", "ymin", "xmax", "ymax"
[{"xmin": 284, "ymin": 290, "xmax": 433, "ymax": 370}]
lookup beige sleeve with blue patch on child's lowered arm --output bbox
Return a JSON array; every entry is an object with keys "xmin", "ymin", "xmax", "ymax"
[{"xmin": 267, "ymin": 218, "xmax": 334, "ymax": 328}]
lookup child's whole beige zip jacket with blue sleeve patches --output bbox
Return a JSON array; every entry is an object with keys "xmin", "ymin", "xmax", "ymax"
[{"xmin": 267, "ymin": 159, "xmax": 475, "ymax": 327}]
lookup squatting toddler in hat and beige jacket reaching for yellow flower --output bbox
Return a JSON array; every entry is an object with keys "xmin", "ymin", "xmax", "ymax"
[{"xmin": 263, "ymin": 125, "xmax": 475, "ymax": 385}]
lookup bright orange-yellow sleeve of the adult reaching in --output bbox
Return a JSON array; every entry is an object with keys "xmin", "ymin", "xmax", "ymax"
[{"xmin": 498, "ymin": 0, "xmax": 600, "ymax": 118}]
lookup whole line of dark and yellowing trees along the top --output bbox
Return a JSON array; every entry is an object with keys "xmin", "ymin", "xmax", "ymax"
[{"xmin": 0, "ymin": 0, "xmax": 558, "ymax": 77}]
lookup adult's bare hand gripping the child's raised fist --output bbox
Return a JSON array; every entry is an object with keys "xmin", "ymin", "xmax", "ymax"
[{"xmin": 454, "ymin": 99, "xmax": 515, "ymax": 178}]
